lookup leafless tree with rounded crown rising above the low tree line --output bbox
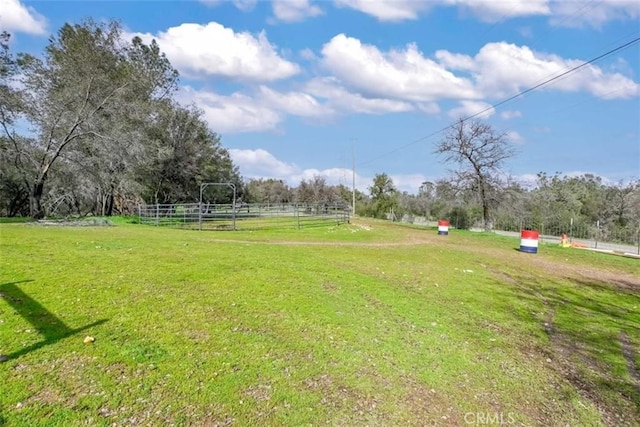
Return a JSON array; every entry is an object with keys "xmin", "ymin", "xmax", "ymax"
[{"xmin": 435, "ymin": 118, "xmax": 515, "ymax": 230}]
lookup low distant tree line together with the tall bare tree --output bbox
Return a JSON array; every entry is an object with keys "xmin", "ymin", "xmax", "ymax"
[{"xmin": 241, "ymin": 119, "xmax": 640, "ymax": 243}]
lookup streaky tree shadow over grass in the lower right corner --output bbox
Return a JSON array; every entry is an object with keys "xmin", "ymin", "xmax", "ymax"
[{"xmin": 482, "ymin": 274, "xmax": 640, "ymax": 425}]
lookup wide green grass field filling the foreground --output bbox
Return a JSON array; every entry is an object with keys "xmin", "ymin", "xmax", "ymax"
[{"xmin": 0, "ymin": 219, "xmax": 640, "ymax": 426}]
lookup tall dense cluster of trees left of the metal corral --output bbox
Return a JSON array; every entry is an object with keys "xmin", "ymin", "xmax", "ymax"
[{"xmin": 0, "ymin": 20, "xmax": 242, "ymax": 218}]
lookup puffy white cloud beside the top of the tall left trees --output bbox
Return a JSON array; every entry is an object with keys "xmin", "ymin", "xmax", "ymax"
[{"xmin": 130, "ymin": 22, "xmax": 300, "ymax": 82}]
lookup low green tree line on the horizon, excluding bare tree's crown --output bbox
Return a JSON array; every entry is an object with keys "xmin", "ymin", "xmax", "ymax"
[{"xmin": 243, "ymin": 172, "xmax": 640, "ymax": 234}]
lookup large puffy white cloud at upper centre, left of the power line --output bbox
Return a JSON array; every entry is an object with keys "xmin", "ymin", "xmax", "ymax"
[{"xmin": 321, "ymin": 34, "xmax": 478, "ymax": 101}]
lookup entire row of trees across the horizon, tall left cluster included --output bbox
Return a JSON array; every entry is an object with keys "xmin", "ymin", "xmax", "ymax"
[{"xmin": 0, "ymin": 20, "xmax": 640, "ymax": 241}]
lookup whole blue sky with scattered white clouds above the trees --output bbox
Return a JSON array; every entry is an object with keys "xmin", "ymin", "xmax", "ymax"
[{"xmin": 0, "ymin": 0, "xmax": 640, "ymax": 193}]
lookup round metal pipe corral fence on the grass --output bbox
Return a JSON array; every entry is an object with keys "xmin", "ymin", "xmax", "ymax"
[{"xmin": 138, "ymin": 203, "xmax": 350, "ymax": 230}]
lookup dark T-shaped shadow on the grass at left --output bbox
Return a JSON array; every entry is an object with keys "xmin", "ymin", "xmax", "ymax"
[{"xmin": 0, "ymin": 280, "xmax": 107, "ymax": 361}]
